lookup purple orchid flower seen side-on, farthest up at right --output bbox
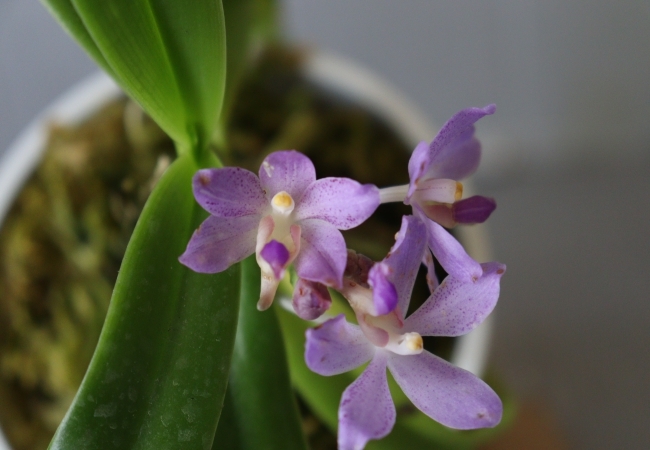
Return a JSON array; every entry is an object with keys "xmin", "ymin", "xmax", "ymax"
[{"xmin": 380, "ymin": 105, "xmax": 496, "ymax": 281}]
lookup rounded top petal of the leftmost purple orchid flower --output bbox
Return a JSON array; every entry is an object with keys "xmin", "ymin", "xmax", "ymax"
[{"xmin": 259, "ymin": 150, "xmax": 316, "ymax": 202}]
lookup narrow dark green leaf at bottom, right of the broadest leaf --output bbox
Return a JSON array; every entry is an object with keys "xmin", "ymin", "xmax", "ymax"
[{"xmin": 213, "ymin": 256, "xmax": 307, "ymax": 450}]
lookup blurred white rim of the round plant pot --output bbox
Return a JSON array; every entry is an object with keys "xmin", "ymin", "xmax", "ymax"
[{"xmin": 0, "ymin": 50, "xmax": 493, "ymax": 450}]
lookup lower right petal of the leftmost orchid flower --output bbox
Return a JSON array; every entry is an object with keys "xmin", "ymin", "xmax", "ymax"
[{"xmin": 293, "ymin": 219, "xmax": 348, "ymax": 287}]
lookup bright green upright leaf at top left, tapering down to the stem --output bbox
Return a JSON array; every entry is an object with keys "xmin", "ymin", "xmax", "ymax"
[{"xmin": 43, "ymin": 0, "xmax": 226, "ymax": 158}]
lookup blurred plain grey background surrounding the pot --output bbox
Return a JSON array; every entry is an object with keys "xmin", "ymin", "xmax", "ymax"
[{"xmin": 0, "ymin": 0, "xmax": 650, "ymax": 449}]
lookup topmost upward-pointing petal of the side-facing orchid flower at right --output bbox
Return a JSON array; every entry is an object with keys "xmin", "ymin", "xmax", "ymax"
[{"xmin": 408, "ymin": 105, "xmax": 496, "ymax": 198}]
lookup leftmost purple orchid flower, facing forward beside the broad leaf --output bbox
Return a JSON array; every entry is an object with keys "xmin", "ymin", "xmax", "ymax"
[{"xmin": 179, "ymin": 151, "xmax": 379, "ymax": 310}]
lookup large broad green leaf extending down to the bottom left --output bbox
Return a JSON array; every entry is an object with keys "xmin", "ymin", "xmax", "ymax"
[{"xmin": 50, "ymin": 155, "xmax": 240, "ymax": 450}]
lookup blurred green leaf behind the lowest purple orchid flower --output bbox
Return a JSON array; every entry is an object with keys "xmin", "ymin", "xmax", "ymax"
[{"xmin": 277, "ymin": 308, "xmax": 513, "ymax": 450}]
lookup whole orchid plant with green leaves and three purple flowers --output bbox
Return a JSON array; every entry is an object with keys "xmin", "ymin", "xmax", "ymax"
[{"xmin": 43, "ymin": 0, "xmax": 505, "ymax": 450}]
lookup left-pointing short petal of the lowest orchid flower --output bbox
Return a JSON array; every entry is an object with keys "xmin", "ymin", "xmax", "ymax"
[{"xmin": 305, "ymin": 314, "xmax": 375, "ymax": 376}]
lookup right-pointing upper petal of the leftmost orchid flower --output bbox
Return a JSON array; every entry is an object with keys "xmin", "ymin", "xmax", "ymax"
[{"xmin": 294, "ymin": 178, "xmax": 379, "ymax": 230}]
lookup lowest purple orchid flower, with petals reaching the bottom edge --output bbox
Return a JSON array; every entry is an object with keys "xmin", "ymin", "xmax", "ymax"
[{"xmin": 305, "ymin": 216, "xmax": 505, "ymax": 450}]
